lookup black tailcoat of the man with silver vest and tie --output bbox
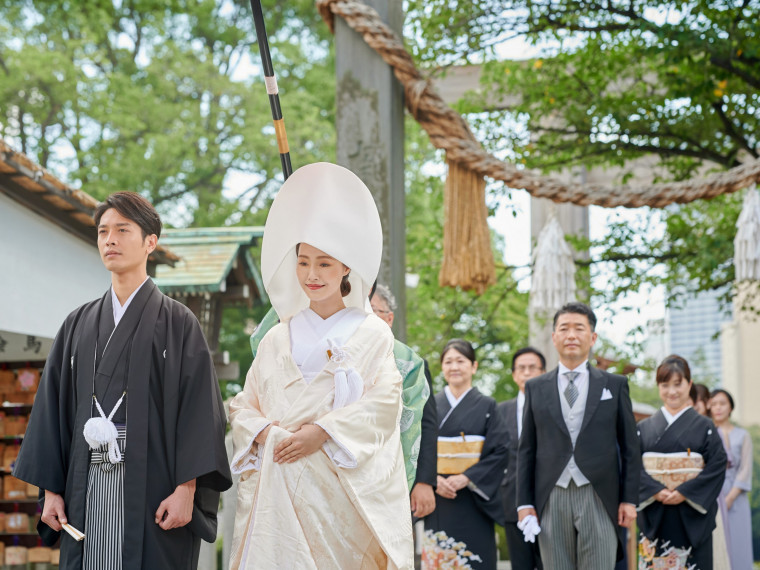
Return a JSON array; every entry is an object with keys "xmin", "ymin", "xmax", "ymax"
[{"xmin": 517, "ymin": 367, "xmax": 641, "ymax": 558}]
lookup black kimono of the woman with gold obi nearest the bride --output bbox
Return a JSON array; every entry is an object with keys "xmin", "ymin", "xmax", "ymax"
[{"xmin": 423, "ymin": 388, "xmax": 509, "ymax": 569}]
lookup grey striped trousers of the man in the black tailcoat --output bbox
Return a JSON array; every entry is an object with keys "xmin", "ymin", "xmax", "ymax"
[{"xmin": 538, "ymin": 481, "xmax": 618, "ymax": 570}]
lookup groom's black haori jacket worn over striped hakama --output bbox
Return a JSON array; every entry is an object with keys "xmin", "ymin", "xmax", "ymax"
[{"xmin": 13, "ymin": 280, "xmax": 232, "ymax": 570}]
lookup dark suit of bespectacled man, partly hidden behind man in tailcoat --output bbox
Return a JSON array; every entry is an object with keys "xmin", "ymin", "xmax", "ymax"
[{"xmin": 498, "ymin": 398, "xmax": 542, "ymax": 570}]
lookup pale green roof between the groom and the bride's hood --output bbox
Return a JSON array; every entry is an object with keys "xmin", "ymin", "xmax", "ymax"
[{"xmin": 155, "ymin": 227, "xmax": 265, "ymax": 295}]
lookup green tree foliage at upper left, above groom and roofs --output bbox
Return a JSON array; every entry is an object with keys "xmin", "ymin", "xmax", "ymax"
[{"xmin": 0, "ymin": 0, "xmax": 335, "ymax": 226}]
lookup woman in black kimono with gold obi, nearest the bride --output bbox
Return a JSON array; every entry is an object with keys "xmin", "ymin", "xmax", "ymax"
[{"xmin": 422, "ymin": 339, "xmax": 509, "ymax": 570}]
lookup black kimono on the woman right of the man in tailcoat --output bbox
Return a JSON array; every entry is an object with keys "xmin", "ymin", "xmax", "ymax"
[{"xmin": 638, "ymin": 408, "xmax": 726, "ymax": 570}]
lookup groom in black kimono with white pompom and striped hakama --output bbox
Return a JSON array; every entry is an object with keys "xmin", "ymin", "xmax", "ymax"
[{"xmin": 13, "ymin": 192, "xmax": 231, "ymax": 570}]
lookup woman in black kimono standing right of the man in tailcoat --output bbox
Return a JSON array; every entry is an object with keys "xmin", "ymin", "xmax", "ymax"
[{"xmin": 638, "ymin": 355, "xmax": 726, "ymax": 570}]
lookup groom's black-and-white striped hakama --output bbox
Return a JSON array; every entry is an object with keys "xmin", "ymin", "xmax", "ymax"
[{"xmin": 82, "ymin": 424, "xmax": 127, "ymax": 570}]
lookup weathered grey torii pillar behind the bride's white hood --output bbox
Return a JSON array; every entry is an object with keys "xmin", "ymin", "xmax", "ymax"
[{"xmin": 335, "ymin": 0, "xmax": 406, "ymax": 341}]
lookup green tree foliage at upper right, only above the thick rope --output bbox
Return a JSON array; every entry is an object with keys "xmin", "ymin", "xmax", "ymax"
[{"xmin": 409, "ymin": 0, "xmax": 760, "ymax": 174}]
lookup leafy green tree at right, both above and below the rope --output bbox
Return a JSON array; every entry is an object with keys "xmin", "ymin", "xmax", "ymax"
[{"xmin": 408, "ymin": 0, "xmax": 760, "ymax": 304}]
